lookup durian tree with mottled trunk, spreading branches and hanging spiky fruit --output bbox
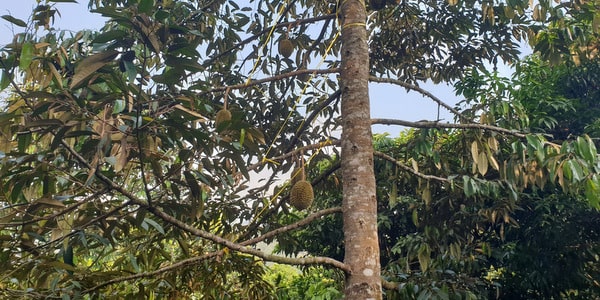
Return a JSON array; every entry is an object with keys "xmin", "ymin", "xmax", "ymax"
[{"xmin": 0, "ymin": 0, "xmax": 599, "ymax": 299}]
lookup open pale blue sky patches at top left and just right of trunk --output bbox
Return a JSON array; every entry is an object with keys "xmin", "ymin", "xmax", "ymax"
[{"xmin": 0, "ymin": 0, "xmax": 468, "ymax": 136}]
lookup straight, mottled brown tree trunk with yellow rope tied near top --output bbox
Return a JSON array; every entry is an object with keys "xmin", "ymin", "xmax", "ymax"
[{"xmin": 339, "ymin": 0, "xmax": 382, "ymax": 300}]
